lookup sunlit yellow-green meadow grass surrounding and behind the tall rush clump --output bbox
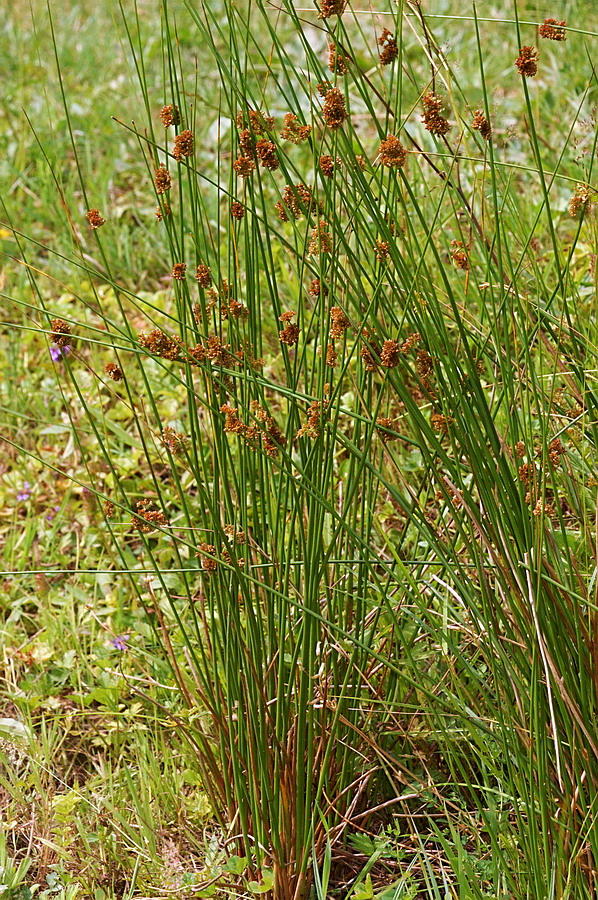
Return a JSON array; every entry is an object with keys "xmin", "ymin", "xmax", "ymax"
[{"xmin": 0, "ymin": 4, "xmax": 596, "ymax": 900}]
